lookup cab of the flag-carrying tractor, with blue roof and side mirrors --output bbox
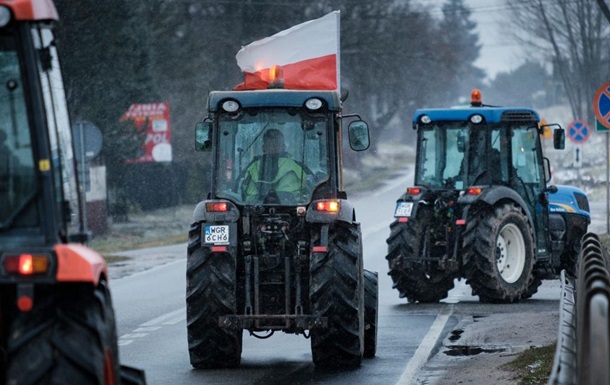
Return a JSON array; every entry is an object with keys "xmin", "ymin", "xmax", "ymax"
[{"xmin": 196, "ymin": 89, "xmax": 369, "ymax": 206}]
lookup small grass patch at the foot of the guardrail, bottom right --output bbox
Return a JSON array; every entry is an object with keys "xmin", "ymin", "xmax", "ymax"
[{"xmin": 502, "ymin": 344, "xmax": 556, "ymax": 385}]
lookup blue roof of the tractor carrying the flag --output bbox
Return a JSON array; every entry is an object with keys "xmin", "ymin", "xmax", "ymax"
[{"xmin": 208, "ymin": 89, "xmax": 341, "ymax": 112}]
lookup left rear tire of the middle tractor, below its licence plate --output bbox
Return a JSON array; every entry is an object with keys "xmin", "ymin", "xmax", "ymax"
[{"xmin": 186, "ymin": 224, "xmax": 243, "ymax": 369}]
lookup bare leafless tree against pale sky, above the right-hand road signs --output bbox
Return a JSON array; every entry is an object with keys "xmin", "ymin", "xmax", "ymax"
[{"xmin": 505, "ymin": 0, "xmax": 610, "ymax": 121}]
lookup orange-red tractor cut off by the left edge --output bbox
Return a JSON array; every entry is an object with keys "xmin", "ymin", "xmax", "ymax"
[{"xmin": 0, "ymin": 0, "xmax": 144, "ymax": 385}]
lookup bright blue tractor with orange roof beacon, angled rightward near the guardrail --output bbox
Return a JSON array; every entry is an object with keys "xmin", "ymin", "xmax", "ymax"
[{"xmin": 386, "ymin": 90, "xmax": 590, "ymax": 303}]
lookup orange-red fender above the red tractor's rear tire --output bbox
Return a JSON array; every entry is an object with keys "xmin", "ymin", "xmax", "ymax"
[{"xmin": 54, "ymin": 243, "xmax": 108, "ymax": 285}]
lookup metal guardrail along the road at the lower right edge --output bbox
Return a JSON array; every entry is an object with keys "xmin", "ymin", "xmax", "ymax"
[{"xmin": 548, "ymin": 233, "xmax": 610, "ymax": 385}]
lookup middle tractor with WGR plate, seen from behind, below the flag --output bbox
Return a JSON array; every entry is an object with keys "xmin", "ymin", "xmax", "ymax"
[{"xmin": 186, "ymin": 89, "xmax": 377, "ymax": 368}]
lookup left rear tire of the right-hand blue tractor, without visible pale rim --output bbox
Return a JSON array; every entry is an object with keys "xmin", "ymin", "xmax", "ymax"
[{"xmin": 386, "ymin": 210, "xmax": 454, "ymax": 303}]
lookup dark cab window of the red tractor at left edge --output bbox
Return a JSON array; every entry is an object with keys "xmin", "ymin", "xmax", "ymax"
[{"xmin": 0, "ymin": 31, "xmax": 37, "ymax": 228}]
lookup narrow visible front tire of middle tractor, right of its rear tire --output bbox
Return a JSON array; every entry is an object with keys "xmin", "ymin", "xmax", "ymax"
[{"xmin": 364, "ymin": 270, "xmax": 379, "ymax": 358}]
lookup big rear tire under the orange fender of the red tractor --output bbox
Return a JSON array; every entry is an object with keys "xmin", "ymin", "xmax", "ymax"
[{"xmin": 6, "ymin": 282, "xmax": 119, "ymax": 385}]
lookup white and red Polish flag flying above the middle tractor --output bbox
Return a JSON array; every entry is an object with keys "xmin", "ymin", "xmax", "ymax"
[{"xmin": 233, "ymin": 11, "xmax": 340, "ymax": 90}]
